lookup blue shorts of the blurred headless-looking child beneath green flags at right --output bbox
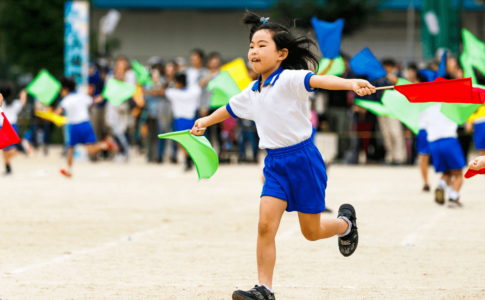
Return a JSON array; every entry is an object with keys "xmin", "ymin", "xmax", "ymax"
[{"xmin": 429, "ymin": 138, "xmax": 466, "ymax": 173}]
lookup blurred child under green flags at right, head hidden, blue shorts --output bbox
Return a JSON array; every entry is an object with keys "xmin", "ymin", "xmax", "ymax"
[{"xmin": 423, "ymin": 104, "xmax": 466, "ymax": 207}]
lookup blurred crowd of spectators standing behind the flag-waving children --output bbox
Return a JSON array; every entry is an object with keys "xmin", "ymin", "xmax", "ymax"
[{"xmin": 1, "ymin": 49, "xmax": 472, "ymax": 169}]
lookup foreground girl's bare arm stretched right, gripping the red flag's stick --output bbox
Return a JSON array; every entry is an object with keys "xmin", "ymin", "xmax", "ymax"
[{"xmin": 310, "ymin": 75, "xmax": 376, "ymax": 96}]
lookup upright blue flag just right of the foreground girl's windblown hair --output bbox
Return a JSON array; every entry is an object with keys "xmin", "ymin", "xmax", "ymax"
[{"xmin": 312, "ymin": 17, "xmax": 345, "ymax": 59}]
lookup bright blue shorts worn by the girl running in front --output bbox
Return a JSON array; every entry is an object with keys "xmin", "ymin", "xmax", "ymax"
[{"xmin": 261, "ymin": 139, "xmax": 327, "ymax": 214}]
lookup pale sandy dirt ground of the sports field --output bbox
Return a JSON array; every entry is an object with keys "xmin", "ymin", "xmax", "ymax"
[{"xmin": 0, "ymin": 152, "xmax": 485, "ymax": 300}]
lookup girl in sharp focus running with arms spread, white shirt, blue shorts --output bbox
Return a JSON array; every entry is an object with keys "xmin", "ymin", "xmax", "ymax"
[{"xmin": 191, "ymin": 12, "xmax": 375, "ymax": 300}]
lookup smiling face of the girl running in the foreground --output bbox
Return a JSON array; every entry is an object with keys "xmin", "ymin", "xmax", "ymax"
[{"xmin": 248, "ymin": 29, "xmax": 288, "ymax": 74}]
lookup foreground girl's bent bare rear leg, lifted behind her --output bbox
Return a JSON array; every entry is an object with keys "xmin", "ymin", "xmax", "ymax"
[{"xmin": 298, "ymin": 212, "xmax": 349, "ymax": 241}]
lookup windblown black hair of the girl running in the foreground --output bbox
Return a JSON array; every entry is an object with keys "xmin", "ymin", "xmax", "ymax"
[{"xmin": 242, "ymin": 10, "xmax": 318, "ymax": 70}]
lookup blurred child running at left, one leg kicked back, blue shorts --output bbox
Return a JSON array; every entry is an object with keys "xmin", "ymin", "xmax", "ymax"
[{"xmin": 56, "ymin": 77, "xmax": 116, "ymax": 178}]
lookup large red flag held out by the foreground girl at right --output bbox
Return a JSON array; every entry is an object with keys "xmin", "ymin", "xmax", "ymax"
[{"xmin": 394, "ymin": 77, "xmax": 482, "ymax": 104}]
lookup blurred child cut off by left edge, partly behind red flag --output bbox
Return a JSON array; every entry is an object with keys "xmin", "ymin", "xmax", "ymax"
[{"xmin": 0, "ymin": 84, "xmax": 27, "ymax": 175}]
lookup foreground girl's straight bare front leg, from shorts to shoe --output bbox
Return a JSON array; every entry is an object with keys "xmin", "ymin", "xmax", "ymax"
[{"xmin": 257, "ymin": 196, "xmax": 288, "ymax": 289}]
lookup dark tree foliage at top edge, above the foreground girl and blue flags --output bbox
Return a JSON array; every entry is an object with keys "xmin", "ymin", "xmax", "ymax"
[{"xmin": 272, "ymin": 0, "xmax": 382, "ymax": 35}]
